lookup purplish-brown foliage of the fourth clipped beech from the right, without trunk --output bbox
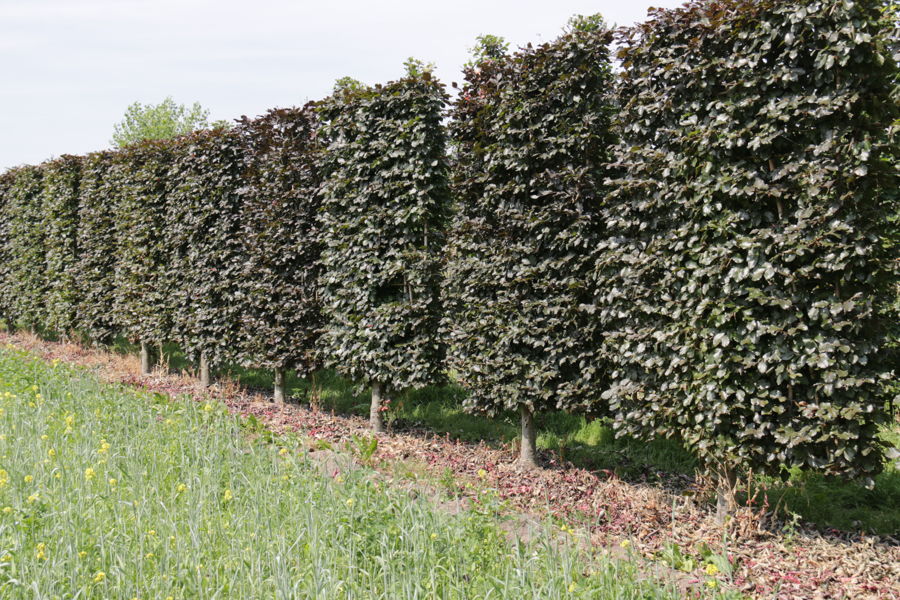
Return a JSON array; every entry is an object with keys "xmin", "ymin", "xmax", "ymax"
[{"xmin": 239, "ymin": 107, "xmax": 322, "ymax": 375}]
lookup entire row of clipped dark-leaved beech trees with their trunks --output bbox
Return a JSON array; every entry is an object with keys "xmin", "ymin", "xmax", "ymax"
[{"xmin": 0, "ymin": 0, "xmax": 898, "ymax": 508}]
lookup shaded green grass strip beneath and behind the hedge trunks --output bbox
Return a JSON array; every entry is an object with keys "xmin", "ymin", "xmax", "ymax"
[{"xmin": 105, "ymin": 336, "xmax": 900, "ymax": 534}]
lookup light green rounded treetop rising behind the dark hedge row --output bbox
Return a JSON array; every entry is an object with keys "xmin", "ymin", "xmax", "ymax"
[{"xmin": 112, "ymin": 96, "xmax": 230, "ymax": 148}]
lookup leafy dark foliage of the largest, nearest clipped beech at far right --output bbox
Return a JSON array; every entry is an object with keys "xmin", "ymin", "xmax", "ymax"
[{"xmin": 598, "ymin": 0, "xmax": 897, "ymax": 490}]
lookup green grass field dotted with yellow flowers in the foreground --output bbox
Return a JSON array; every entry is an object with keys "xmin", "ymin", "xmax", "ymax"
[{"xmin": 0, "ymin": 347, "xmax": 740, "ymax": 599}]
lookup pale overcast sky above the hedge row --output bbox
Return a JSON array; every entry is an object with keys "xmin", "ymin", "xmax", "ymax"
[{"xmin": 0, "ymin": 0, "xmax": 682, "ymax": 170}]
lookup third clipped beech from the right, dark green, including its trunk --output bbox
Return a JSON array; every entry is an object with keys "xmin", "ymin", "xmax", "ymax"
[{"xmin": 320, "ymin": 72, "xmax": 450, "ymax": 428}]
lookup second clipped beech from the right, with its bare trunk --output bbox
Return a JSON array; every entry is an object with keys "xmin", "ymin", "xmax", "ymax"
[{"xmin": 448, "ymin": 12, "xmax": 615, "ymax": 463}]
